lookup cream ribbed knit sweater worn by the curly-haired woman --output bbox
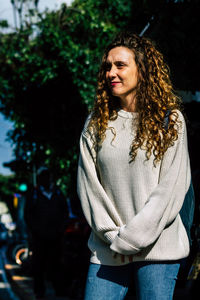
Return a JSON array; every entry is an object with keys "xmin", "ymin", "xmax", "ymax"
[{"xmin": 78, "ymin": 110, "xmax": 191, "ymax": 265}]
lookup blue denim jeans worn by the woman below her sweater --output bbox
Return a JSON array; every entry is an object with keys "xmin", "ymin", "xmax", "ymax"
[{"xmin": 84, "ymin": 261, "xmax": 180, "ymax": 300}]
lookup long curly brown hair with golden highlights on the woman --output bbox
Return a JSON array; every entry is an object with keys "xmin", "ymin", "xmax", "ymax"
[{"xmin": 88, "ymin": 32, "xmax": 182, "ymax": 163}]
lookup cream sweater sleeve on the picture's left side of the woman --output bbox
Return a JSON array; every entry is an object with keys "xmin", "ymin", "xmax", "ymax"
[{"xmin": 77, "ymin": 125, "xmax": 123, "ymax": 244}]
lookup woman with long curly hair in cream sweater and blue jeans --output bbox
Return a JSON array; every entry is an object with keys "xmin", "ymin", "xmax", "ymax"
[{"xmin": 78, "ymin": 33, "xmax": 191, "ymax": 300}]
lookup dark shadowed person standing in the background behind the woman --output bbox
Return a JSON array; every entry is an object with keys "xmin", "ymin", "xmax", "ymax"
[{"xmin": 24, "ymin": 167, "xmax": 68, "ymax": 298}]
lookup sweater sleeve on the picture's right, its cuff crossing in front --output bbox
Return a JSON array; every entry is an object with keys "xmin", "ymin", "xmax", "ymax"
[{"xmin": 110, "ymin": 112, "xmax": 191, "ymax": 255}]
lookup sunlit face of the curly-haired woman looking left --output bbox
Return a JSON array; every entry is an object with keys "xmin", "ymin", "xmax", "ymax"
[{"xmin": 106, "ymin": 47, "xmax": 138, "ymax": 101}]
